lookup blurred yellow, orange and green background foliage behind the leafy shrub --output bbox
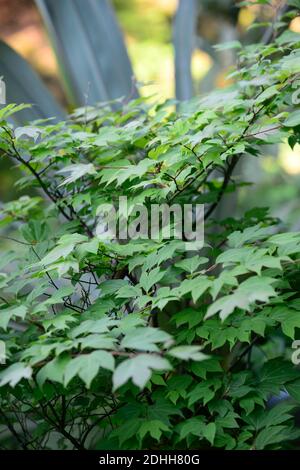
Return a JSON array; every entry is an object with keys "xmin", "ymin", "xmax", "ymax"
[{"xmin": 0, "ymin": 0, "xmax": 300, "ymax": 230}]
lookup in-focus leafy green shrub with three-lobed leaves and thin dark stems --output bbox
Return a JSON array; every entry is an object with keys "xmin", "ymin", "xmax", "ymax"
[{"xmin": 0, "ymin": 4, "xmax": 300, "ymax": 450}]
